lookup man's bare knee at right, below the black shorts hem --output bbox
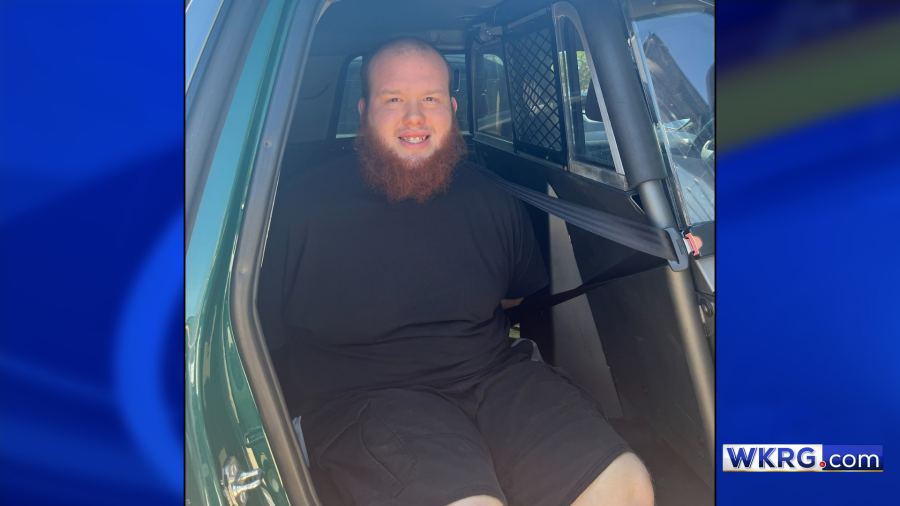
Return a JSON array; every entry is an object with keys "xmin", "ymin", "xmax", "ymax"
[{"xmin": 572, "ymin": 453, "xmax": 653, "ymax": 506}]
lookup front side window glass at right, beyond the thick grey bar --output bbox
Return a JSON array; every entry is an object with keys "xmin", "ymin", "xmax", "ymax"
[{"xmin": 633, "ymin": 12, "xmax": 716, "ymax": 225}]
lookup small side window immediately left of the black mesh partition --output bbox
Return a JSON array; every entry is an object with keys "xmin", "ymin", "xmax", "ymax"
[{"xmin": 475, "ymin": 41, "xmax": 512, "ymax": 140}]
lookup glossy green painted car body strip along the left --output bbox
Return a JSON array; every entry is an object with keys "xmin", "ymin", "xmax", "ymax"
[{"xmin": 185, "ymin": 0, "xmax": 297, "ymax": 506}]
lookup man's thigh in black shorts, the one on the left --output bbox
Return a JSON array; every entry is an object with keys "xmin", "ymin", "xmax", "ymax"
[{"xmin": 301, "ymin": 389, "xmax": 504, "ymax": 506}]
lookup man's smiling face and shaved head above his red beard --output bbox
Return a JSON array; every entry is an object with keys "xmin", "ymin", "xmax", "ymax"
[{"xmin": 359, "ymin": 51, "xmax": 456, "ymax": 167}]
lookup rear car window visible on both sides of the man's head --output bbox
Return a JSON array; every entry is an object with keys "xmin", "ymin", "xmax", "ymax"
[{"xmin": 335, "ymin": 54, "xmax": 470, "ymax": 139}]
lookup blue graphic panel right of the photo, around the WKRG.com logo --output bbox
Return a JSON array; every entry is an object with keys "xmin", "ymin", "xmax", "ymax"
[{"xmin": 716, "ymin": 1, "xmax": 900, "ymax": 505}]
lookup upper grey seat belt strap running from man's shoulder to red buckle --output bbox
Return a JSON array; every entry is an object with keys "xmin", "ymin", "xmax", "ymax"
[{"xmin": 466, "ymin": 162, "xmax": 688, "ymax": 271}]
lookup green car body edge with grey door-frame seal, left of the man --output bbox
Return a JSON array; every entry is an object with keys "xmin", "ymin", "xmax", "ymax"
[{"xmin": 185, "ymin": 0, "xmax": 326, "ymax": 505}]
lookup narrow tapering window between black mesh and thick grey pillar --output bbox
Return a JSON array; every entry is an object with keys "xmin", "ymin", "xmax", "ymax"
[{"xmin": 560, "ymin": 18, "xmax": 615, "ymax": 171}]
